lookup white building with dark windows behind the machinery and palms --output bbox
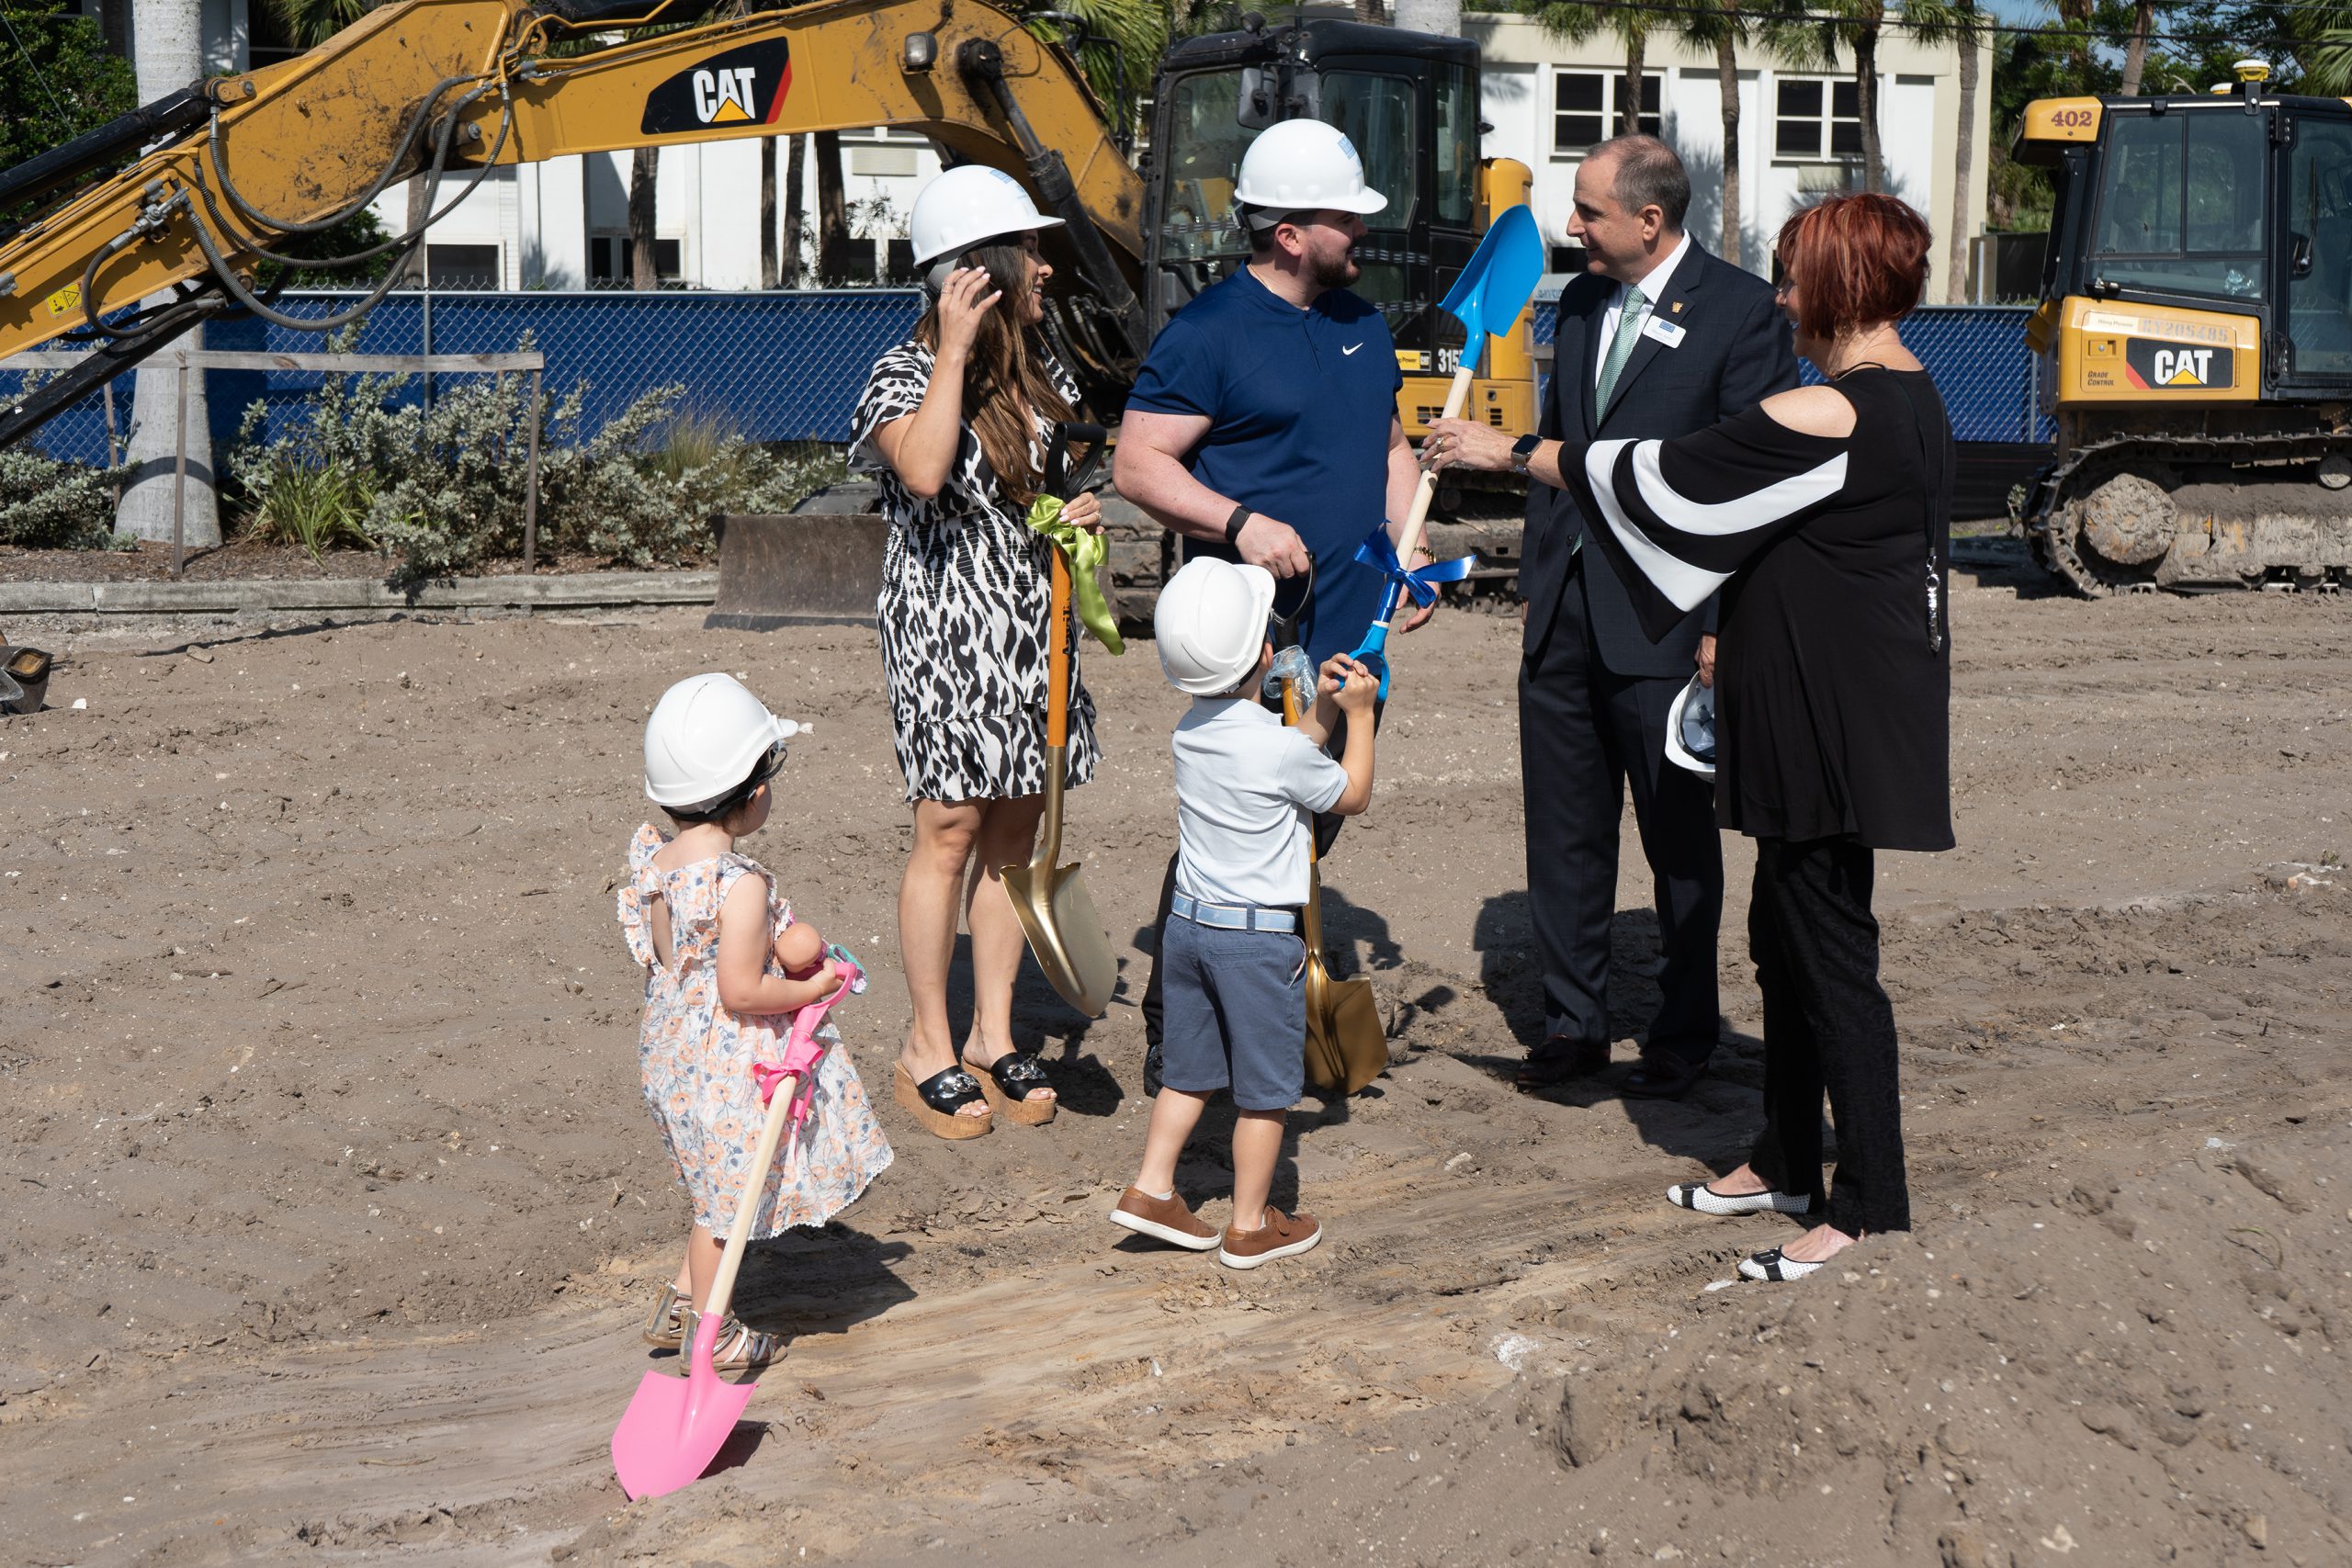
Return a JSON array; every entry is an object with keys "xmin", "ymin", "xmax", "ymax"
[{"xmin": 106, "ymin": 0, "xmax": 1992, "ymax": 301}]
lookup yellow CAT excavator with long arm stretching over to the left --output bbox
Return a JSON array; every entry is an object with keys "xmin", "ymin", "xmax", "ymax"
[{"xmin": 0, "ymin": 0, "xmax": 1533, "ymax": 460}]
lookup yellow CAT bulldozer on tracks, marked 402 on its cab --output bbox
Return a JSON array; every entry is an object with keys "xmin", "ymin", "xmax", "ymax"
[{"xmin": 2016, "ymin": 62, "xmax": 2352, "ymax": 597}]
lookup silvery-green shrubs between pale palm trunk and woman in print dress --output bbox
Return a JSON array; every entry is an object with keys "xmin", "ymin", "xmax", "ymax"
[{"xmin": 228, "ymin": 339, "xmax": 840, "ymax": 579}]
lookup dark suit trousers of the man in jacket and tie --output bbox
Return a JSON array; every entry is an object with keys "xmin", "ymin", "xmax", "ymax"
[{"xmin": 1520, "ymin": 583, "xmax": 1724, "ymax": 1065}]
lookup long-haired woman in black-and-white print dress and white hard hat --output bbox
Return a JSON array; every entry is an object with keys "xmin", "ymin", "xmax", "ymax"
[{"xmin": 852, "ymin": 164, "xmax": 1101, "ymax": 1138}]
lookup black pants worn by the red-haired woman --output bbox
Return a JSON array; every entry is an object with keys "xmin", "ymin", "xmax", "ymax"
[{"xmin": 1747, "ymin": 840, "xmax": 1910, "ymax": 1236}]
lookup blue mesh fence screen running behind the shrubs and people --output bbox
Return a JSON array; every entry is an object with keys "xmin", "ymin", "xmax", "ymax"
[{"xmin": 9, "ymin": 289, "xmax": 2051, "ymax": 463}]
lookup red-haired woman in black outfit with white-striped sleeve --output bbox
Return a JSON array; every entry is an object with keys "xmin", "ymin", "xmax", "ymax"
[{"xmin": 1428, "ymin": 195, "xmax": 1952, "ymax": 1279}]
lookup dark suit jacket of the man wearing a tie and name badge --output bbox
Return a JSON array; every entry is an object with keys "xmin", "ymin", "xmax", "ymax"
[{"xmin": 1520, "ymin": 240, "xmax": 1797, "ymax": 680}]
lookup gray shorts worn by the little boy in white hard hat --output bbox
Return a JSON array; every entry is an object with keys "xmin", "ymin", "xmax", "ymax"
[{"xmin": 1159, "ymin": 915, "xmax": 1307, "ymax": 1110}]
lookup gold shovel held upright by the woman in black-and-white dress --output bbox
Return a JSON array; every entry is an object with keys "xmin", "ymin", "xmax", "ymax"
[{"xmin": 1000, "ymin": 425, "xmax": 1120, "ymax": 1018}]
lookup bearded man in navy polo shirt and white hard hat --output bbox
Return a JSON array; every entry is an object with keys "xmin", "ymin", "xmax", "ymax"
[{"xmin": 1113, "ymin": 120, "xmax": 1430, "ymax": 1093}]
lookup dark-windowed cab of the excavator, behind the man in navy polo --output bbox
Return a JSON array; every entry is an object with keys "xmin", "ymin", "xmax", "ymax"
[{"xmin": 1143, "ymin": 21, "xmax": 1536, "ymax": 437}]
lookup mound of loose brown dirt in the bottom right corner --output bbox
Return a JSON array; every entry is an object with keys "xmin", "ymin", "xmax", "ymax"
[{"xmin": 1547, "ymin": 1128, "xmax": 2352, "ymax": 1568}]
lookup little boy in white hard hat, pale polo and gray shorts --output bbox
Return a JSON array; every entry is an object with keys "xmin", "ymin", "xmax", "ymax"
[{"xmin": 1110, "ymin": 558, "xmax": 1381, "ymax": 1269}]
